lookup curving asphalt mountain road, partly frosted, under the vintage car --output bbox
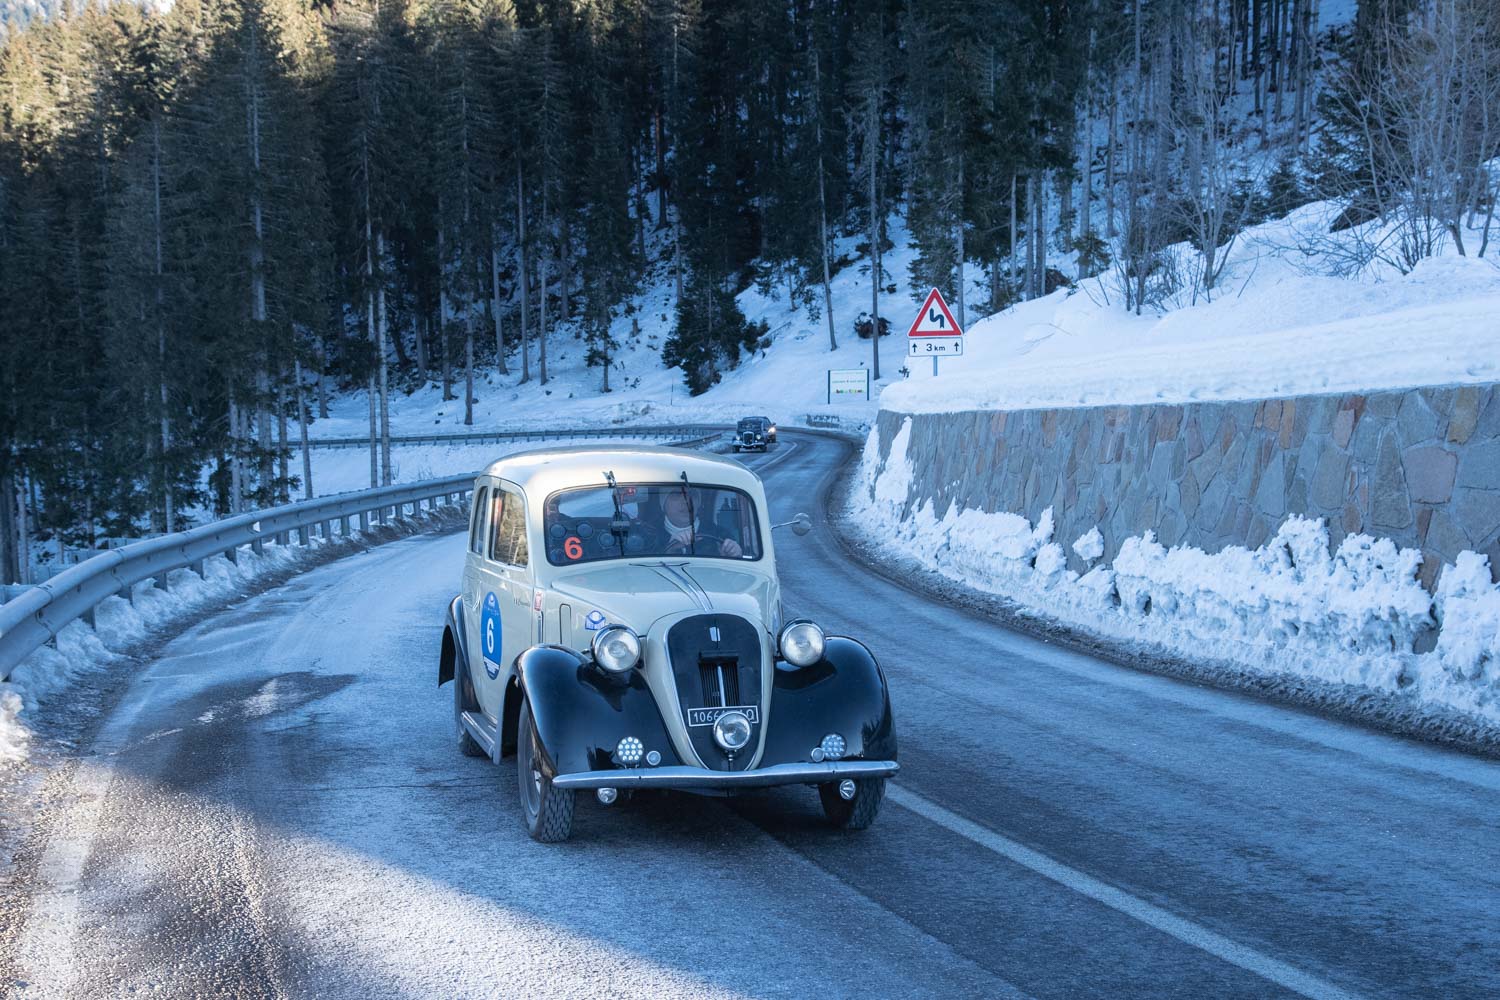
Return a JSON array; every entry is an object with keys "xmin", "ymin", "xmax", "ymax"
[{"xmin": 9, "ymin": 435, "xmax": 1500, "ymax": 999}]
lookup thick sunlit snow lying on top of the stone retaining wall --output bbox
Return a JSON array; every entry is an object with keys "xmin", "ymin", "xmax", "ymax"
[{"xmin": 882, "ymin": 202, "xmax": 1500, "ymax": 412}]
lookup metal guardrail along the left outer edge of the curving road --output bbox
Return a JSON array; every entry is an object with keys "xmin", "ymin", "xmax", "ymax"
[{"xmin": 0, "ymin": 424, "xmax": 725, "ymax": 681}]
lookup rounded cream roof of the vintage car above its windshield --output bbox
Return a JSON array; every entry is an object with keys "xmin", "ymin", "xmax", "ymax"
[{"xmin": 480, "ymin": 444, "xmax": 762, "ymax": 498}]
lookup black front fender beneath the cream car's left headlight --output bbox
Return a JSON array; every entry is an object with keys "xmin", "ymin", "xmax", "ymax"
[{"xmin": 516, "ymin": 646, "xmax": 681, "ymax": 777}]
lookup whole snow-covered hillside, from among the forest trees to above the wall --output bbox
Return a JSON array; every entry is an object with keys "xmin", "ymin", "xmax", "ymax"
[{"xmin": 325, "ymin": 202, "xmax": 1500, "ymax": 446}]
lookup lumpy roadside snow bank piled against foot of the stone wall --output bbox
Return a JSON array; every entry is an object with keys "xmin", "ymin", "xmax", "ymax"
[{"xmin": 849, "ymin": 420, "xmax": 1500, "ymax": 723}]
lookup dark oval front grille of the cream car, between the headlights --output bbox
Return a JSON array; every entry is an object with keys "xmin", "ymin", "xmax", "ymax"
[{"xmin": 666, "ymin": 615, "xmax": 765, "ymax": 771}]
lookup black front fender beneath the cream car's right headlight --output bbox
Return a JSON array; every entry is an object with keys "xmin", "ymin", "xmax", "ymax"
[{"xmin": 761, "ymin": 636, "xmax": 896, "ymax": 766}]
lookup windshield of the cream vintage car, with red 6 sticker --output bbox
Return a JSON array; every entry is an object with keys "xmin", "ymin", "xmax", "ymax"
[{"xmin": 542, "ymin": 483, "xmax": 761, "ymax": 565}]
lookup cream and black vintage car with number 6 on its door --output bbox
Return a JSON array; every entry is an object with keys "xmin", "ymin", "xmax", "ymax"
[{"xmin": 438, "ymin": 447, "xmax": 897, "ymax": 841}]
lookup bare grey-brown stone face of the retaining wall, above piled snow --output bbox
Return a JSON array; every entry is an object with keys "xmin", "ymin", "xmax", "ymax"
[{"xmin": 876, "ymin": 384, "xmax": 1500, "ymax": 588}]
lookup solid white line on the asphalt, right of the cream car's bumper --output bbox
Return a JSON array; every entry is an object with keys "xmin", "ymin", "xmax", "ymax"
[{"xmin": 885, "ymin": 784, "xmax": 1358, "ymax": 1000}]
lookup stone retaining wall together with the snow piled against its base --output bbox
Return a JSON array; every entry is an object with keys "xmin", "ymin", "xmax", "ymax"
[{"xmin": 851, "ymin": 385, "xmax": 1500, "ymax": 723}]
